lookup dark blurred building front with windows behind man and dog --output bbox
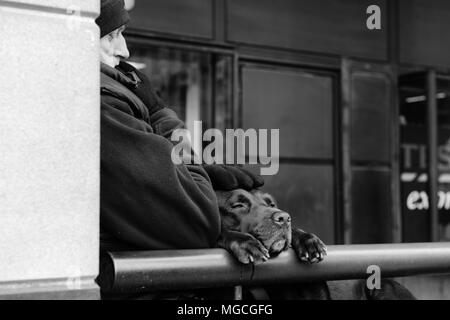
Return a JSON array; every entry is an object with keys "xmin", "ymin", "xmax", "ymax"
[{"xmin": 122, "ymin": 0, "xmax": 450, "ymax": 298}]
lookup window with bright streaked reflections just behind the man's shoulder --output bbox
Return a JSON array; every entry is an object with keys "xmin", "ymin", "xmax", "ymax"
[{"xmin": 128, "ymin": 39, "xmax": 233, "ymax": 138}]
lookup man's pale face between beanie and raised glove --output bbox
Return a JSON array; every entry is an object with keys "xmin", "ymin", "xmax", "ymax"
[{"xmin": 100, "ymin": 26, "xmax": 130, "ymax": 68}]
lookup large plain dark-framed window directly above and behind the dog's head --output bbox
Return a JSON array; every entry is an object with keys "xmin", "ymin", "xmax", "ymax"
[{"xmin": 240, "ymin": 62, "xmax": 339, "ymax": 244}]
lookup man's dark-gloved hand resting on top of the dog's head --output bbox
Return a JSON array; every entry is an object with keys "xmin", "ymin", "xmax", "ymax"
[{"xmin": 203, "ymin": 164, "xmax": 264, "ymax": 191}]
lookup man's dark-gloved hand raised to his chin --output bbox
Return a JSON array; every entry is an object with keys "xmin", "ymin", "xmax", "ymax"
[{"xmin": 117, "ymin": 61, "xmax": 165, "ymax": 115}]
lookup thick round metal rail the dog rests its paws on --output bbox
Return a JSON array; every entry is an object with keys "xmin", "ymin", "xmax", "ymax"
[{"xmin": 98, "ymin": 242, "xmax": 450, "ymax": 292}]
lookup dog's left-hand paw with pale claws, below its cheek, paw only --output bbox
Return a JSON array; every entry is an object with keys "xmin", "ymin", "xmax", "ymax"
[{"xmin": 229, "ymin": 234, "xmax": 270, "ymax": 265}]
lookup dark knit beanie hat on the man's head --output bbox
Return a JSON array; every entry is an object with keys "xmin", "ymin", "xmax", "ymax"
[{"xmin": 95, "ymin": 0, "xmax": 130, "ymax": 38}]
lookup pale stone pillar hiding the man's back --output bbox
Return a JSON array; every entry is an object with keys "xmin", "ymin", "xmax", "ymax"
[{"xmin": 0, "ymin": 0, "xmax": 100, "ymax": 299}]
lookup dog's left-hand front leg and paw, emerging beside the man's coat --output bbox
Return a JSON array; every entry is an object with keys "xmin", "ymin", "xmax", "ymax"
[{"xmin": 217, "ymin": 230, "xmax": 270, "ymax": 264}]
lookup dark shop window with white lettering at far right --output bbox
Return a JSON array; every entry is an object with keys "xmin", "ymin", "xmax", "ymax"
[{"xmin": 399, "ymin": 73, "xmax": 450, "ymax": 242}]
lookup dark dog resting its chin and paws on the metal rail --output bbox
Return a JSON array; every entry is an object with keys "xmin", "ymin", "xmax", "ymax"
[{"xmin": 216, "ymin": 189, "xmax": 415, "ymax": 300}]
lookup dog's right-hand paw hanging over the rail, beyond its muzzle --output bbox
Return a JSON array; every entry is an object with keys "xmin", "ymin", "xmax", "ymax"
[{"xmin": 292, "ymin": 229, "xmax": 327, "ymax": 263}]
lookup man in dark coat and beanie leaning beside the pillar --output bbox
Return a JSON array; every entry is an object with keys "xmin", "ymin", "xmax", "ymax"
[{"xmin": 96, "ymin": 0, "xmax": 263, "ymax": 255}]
